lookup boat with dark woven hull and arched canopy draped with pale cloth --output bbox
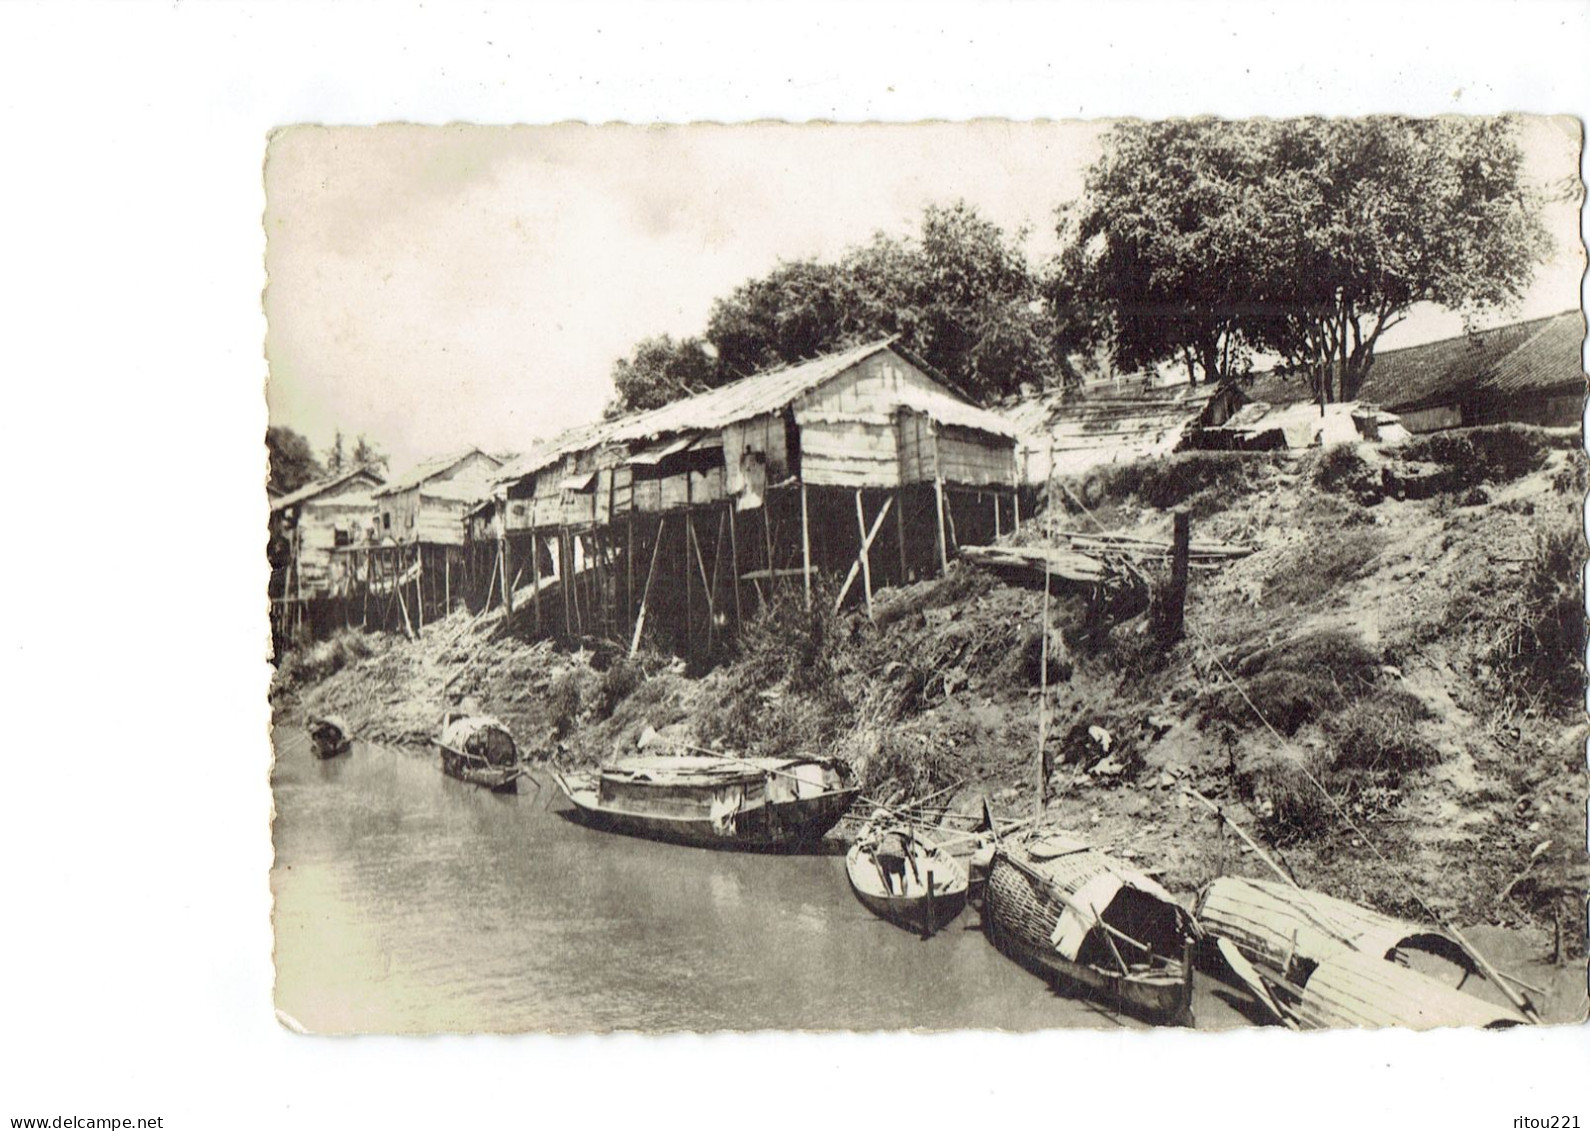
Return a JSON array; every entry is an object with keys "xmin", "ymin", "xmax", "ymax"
[{"xmin": 983, "ymin": 832, "xmax": 1200, "ymax": 1024}]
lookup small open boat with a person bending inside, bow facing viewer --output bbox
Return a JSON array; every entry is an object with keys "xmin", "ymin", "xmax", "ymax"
[{"xmin": 844, "ymin": 824, "xmax": 968, "ymax": 937}]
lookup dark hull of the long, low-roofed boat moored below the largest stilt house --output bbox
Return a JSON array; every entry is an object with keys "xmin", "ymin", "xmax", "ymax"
[{"xmin": 557, "ymin": 776, "xmax": 860, "ymax": 853}]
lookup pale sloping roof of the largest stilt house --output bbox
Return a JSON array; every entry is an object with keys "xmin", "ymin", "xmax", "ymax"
[{"xmin": 494, "ymin": 337, "xmax": 1016, "ymax": 484}]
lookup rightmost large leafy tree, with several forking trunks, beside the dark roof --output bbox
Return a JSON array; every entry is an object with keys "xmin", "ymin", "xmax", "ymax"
[{"xmin": 1248, "ymin": 116, "xmax": 1550, "ymax": 401}]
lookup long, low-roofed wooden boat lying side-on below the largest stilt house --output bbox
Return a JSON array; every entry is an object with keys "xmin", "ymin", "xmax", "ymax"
[{"xmin": 553, "ymin": 754, "xmax": 860, "ymax": 851}]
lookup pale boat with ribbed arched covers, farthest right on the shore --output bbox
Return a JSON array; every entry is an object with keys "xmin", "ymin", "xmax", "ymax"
[{"xmin": 1196, "ymin": 876, "xmax": 1530, "ymax": 1029}]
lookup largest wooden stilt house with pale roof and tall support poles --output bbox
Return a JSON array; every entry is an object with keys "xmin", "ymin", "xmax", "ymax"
[{"xmin": 474, "ymin": 340, "xmax": 1019, "ymax": 657}]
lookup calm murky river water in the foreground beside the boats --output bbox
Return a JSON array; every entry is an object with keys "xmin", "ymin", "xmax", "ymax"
[{"xmin": 272, "ymin": 729, "xmax": 1240, "ymax": 1032}]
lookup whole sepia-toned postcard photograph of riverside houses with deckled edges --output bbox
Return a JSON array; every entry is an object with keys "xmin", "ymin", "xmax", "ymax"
[{"xmin": 266, "ymin": 115, "xmax": 1590, "ymax": 1032}]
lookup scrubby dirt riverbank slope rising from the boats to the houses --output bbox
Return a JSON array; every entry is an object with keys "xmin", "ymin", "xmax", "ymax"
[{"xmin": 275, "ymin": 428, "xmax": 1590, "ymax": 954}]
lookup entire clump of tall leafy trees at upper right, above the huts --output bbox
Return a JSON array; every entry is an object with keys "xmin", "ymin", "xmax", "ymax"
[{"xmin": 1049, "ymin": 116, "xmax": 1547, "ymax": 399}]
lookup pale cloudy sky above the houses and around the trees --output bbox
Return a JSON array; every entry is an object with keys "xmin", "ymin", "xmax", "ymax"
[{"xmin": 266, "ymin": 119, "xmax": 1584, "ymax": 471}]
